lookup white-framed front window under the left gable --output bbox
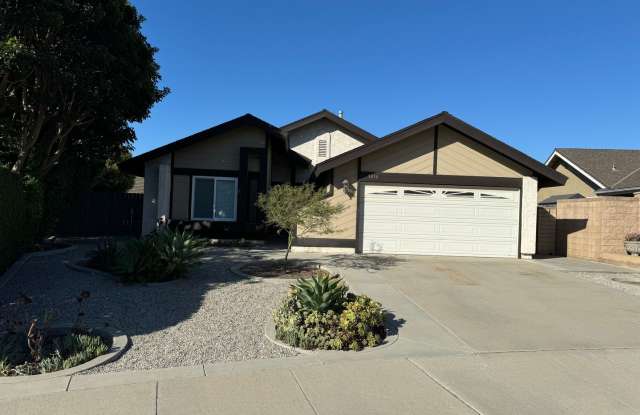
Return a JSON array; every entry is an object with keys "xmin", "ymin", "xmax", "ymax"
[{"xmin": 191, "ymin": 176, "xmax": 238, "ymax": 221}]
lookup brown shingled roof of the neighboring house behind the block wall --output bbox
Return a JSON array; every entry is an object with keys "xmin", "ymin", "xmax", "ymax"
[{"xmin": 545, "ymin": 148, "xmax": 640, "ymax": 190}]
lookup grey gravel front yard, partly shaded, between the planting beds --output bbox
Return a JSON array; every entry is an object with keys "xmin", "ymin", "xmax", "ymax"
[{"xmin": 0, "ymin": 245, "xmax": 294, "ymax": 373}]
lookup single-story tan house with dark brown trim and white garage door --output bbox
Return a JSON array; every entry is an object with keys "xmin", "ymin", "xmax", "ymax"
[{"xmin": 121, "ymin": 111, "xmax": 566, "ymax": 258}]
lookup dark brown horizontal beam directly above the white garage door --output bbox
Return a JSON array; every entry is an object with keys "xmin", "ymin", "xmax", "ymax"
[{"xmin": 360, "ymin": 173, "xmax": 522, "ymax": 189}]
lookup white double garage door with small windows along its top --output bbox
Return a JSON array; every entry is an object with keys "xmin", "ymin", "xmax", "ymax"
[{"xmin": 362, "ymin": 184, "xmax": 520, "ymax": 257}]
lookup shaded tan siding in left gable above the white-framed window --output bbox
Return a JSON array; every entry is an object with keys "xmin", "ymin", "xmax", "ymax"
[{"xmin": 174, "ymin": 127, "xmax": 265, "ymax": 170}]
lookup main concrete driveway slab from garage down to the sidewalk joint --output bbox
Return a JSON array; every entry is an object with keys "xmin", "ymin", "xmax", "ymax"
[{"xmin": 343, "ymin": 257, "xmax": 640, "ymax": 352}]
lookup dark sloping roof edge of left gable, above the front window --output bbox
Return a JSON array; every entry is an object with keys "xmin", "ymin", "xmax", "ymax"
[{"xmin": 119, "ymin": 114, "xmax": 284, "ymax": 175}]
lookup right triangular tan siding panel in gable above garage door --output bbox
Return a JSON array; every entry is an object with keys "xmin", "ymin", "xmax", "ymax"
[{"xmin": 437, "ymin": 126, "xmax": 531, "ymax": 177}]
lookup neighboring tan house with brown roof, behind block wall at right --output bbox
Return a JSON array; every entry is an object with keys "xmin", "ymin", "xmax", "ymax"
[{"xmin": 538, "ymin": 148, "xmax": 640, "ymax": 205}]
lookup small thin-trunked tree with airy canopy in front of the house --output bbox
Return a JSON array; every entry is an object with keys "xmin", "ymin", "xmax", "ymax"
[{"xmin": 257, "ymin": 184, "xmax": 344, "ymax": 272}]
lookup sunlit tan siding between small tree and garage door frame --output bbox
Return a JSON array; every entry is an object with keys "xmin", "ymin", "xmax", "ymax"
[{"xmin": 304, "ymin": 160, "xmax": 358, "ymax": 239}]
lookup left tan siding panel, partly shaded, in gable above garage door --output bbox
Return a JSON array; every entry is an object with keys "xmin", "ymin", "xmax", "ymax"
[{"xmin": 361, "ymin": 129, "xmax": 433, "ymax": 174}]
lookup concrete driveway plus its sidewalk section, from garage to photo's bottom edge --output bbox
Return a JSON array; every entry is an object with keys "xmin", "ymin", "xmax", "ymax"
[{"xmin": 324, "ymin": 257, "xmax": 640, "ymax": 414}]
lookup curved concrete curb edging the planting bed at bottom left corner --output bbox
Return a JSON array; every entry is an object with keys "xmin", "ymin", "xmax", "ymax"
[{"xmin": 0, "ymin": 327, "xmax": 129, "ymax": 385}]
